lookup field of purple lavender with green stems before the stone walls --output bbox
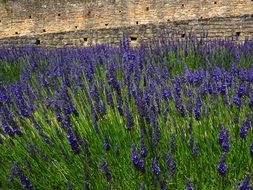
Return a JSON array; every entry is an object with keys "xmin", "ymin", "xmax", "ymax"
[{"xmin": 0, "ymin": 37, "xmax": 253, "ymax": 190}]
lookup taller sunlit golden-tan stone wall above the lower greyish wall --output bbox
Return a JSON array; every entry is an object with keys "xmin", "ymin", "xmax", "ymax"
[{"xmin": 0, "ymin": 0, "xmax": 253, "ymax": 38}]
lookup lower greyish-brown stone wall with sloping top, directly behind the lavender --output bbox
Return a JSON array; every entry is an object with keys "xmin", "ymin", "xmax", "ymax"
[{"xmin": 0, "ymin": 14, "xmax": 253, "ymax": 46}]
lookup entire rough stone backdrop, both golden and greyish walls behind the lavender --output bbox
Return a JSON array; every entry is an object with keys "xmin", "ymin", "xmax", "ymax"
[{"xmin": 0, "ymin": 0, "xmax": 253, "ymax": 46}]
